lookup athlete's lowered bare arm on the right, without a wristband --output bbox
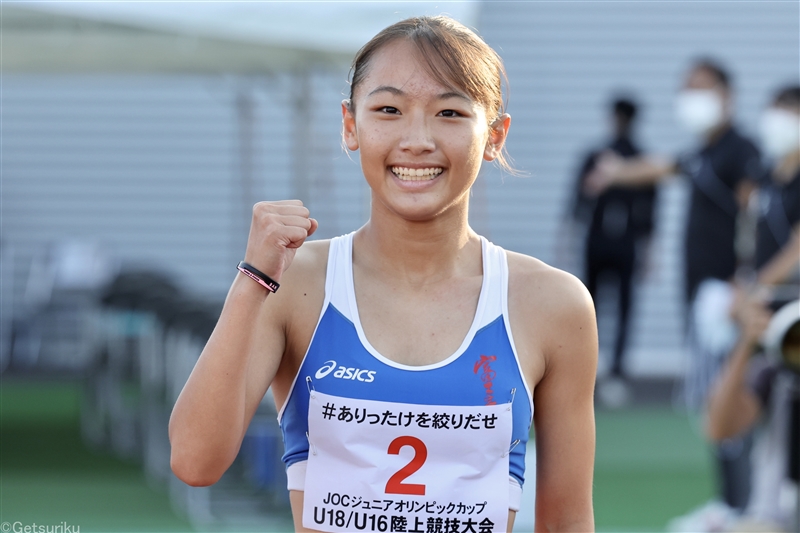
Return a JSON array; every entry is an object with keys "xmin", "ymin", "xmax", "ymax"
[{"xmin": 534, "ymin": 271, "xmax": 597, "ymax": 533}]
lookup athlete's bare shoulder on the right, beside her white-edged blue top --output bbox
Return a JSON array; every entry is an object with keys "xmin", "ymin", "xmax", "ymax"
[{"xmin": 506, "ymin": 252, "xmax": 597, "ymax": 383}]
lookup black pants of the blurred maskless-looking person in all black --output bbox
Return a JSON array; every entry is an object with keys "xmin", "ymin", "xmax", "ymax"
[{"xmin": 585, "ymin": 234, "xmax": 636, "ymax": 377}]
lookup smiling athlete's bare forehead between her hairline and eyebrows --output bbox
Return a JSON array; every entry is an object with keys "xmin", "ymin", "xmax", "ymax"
[{"xmin": 354, "ymin": 40, "xmax": 472, "ymax": 103}]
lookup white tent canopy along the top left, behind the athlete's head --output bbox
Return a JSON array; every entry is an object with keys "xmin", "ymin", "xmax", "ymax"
[{"xmin": 2, "ymin": 2, "xmax": 477, "ymax": 74}]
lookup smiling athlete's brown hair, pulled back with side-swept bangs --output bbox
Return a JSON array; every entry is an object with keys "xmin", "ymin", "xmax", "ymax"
[{"xmin": 350, "ymin": 16, "xmax": 514, "ymax": 173}]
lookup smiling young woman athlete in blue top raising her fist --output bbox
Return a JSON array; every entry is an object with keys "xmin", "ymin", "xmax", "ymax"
[{"xmin": 170, "ymin": 17, "xmax": 597, "ymax": 533}]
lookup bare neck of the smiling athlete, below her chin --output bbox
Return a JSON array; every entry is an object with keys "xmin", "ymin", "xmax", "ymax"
[{"xmin": 354, "ymin": 195, "xmax": 480, "ymax": 286}]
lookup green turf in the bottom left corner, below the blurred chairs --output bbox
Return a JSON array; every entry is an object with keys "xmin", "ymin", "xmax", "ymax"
[{"xmin": 0, "ymin": 382, "xmax": 192, "ymax": 532}]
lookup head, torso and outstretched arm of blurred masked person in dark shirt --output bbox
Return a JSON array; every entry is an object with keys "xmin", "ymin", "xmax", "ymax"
[{"xmin": 586, "ymin": 59, "xmax": 760, "ymax": 302}]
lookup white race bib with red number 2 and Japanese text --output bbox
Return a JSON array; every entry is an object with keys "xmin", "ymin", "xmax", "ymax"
[{"xmin": 303, "ymin": 391, "xmax": 512, "ymax": 533}]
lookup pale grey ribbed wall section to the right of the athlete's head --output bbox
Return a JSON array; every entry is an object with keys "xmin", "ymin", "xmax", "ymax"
[{"xmin": 479, "ymin": 1, "xmax": 800, "ymax": 374}]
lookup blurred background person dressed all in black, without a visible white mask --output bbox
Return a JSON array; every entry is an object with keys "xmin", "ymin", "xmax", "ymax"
[{"xmin": 571, "ymin": 98, "xmax": 656, "ymax": 407}]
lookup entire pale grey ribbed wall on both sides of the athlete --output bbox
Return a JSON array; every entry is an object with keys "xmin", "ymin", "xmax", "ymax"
[{"xmin": 0, "ymin": 1, "xmax": 800, "ymax": 374}]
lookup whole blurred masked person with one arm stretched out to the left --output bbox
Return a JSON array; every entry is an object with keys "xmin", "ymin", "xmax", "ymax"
[{"xmin": 587, "ymin": 59, "xmax": 761, "ymax": 510}]
